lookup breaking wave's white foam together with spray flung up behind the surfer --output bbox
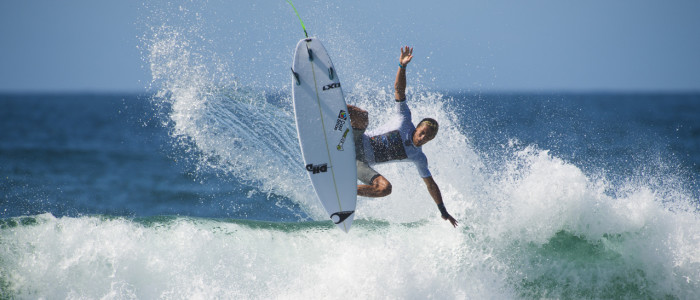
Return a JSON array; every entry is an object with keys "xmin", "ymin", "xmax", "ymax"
[{"xmin": 0, "ymin": 4, "xmax": 700, "ymax": 299}]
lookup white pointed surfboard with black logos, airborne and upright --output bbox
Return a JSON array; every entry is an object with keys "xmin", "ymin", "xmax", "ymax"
[{"xmin": 292, "ymin": 38, "xmax": 357, "ymax": 232}]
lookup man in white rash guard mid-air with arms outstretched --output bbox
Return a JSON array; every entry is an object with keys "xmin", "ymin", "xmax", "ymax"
[{"xmin": 348, "ymin": 46, "xmax": 457, "ymax": 227}]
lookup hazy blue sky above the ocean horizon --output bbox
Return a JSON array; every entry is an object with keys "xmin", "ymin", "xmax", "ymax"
[{"xmin": 0, "ymin": 0, "xmax": 700, "ymax": 92}]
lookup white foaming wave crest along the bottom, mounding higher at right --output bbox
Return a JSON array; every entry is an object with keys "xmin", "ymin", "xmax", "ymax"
[{"xmin": 5, "ymin": 170, "xmax": 700, "ymax": 299}]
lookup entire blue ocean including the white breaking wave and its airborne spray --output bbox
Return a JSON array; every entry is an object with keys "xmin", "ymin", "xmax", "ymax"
[{"xmin": 0, "ymin": 2, "xmax": 700, "ymax": 299}]
